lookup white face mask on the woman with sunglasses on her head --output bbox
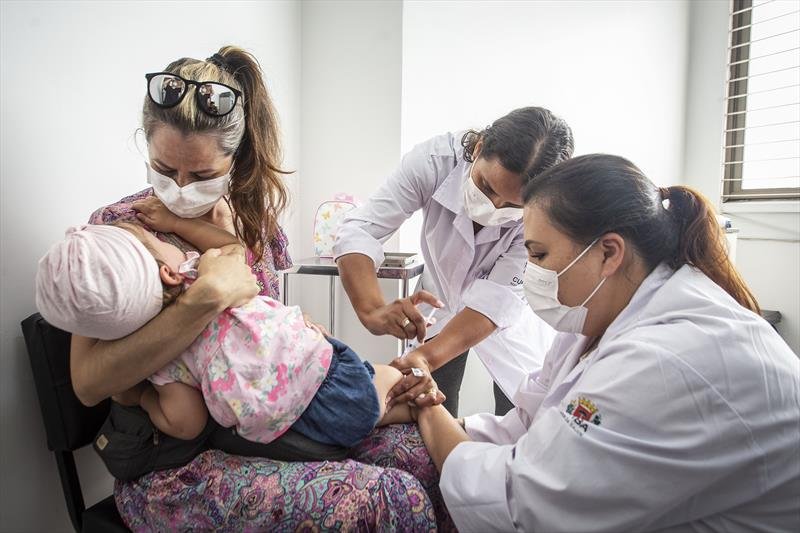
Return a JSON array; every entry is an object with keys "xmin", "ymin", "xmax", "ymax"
[{"xmin": 145, "ymin": 162, "xmax": 231, "ymax": 218}]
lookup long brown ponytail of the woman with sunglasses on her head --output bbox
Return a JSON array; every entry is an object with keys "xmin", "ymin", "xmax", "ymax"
[{"xmin": 219, "ymin": 46, "xmax": 289, "ymax": 260}]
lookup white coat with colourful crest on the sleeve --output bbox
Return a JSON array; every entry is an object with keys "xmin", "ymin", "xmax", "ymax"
[{"xmin": 440, "ymin": 265, "xmax": 800, "ymax": 532}]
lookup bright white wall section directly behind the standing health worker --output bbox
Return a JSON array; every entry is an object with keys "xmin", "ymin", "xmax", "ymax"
[{"xmin": 400, "ymin": 0, "xmax": 688, "ymax": 413}]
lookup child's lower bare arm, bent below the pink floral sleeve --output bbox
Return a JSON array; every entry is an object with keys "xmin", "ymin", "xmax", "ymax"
[{"xmin": 139, "ymin": 382, "xmax": 208, "ymax": 440}]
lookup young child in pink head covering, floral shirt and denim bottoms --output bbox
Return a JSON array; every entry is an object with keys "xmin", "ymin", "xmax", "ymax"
[{"xmin": 36, "ymin": 198, "xmax": 441, "ymax": 447}]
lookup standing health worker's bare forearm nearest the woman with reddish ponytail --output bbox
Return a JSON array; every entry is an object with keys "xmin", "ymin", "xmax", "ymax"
[{"xmin": 419, "ymin": 307, "xmax": 497, "ymax": 370}]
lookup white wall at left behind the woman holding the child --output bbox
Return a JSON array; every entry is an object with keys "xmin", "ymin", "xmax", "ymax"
[{"xmin": 0, "ymin": 1, "xmax": 300, "ymax": 532}]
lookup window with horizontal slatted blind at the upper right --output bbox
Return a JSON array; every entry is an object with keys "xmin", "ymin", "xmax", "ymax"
[{"xmin": 722, "ymin": 0, "xmax": 800, "ymax": 201}]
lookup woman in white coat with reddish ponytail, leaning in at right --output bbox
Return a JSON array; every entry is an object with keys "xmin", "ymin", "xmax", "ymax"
[{"xmin": 417, "ymin": 155, "xmax": 800, "ymax": 533}]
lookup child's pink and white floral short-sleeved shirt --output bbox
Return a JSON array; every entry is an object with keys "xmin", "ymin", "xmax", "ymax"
[{"xmin": 149, "ymin": 296, "xmax": 333, "ymax": 443}]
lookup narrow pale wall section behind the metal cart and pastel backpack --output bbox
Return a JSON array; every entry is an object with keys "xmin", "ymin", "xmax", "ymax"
[{"xmin": 289, "ymin": 0, "xmax": 402, "ymax": 362}]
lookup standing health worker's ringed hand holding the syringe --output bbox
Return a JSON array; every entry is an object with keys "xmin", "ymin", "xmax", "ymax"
[{"xmin": 358, "ymin": 291, "xmax": 444, "ymax": 342}]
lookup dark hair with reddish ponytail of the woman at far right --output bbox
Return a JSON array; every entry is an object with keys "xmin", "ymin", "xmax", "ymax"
[{"xmin": 523, "ymin": 154, "xmax": 759, "ymax": 313}]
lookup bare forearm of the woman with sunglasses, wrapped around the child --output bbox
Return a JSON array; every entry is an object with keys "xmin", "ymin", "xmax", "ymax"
[{"xmin": 70, "ymin": 279, "xmax": 224, "ymax": 405}]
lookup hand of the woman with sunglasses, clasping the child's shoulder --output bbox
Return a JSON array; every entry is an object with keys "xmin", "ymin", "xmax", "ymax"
[{"xmin": 188, "ymin": 245, "xmax": 259, "ymax": 312}]
